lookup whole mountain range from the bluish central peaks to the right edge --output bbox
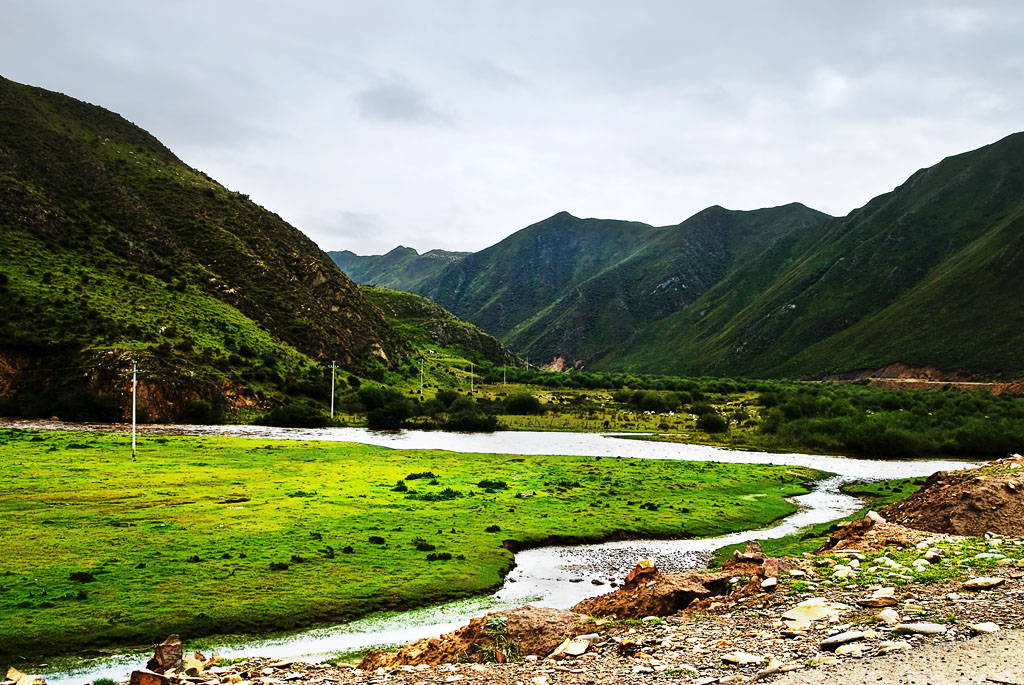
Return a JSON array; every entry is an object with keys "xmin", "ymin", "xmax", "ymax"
[{"xmin": 335, "ymin": 133, "xmax": 1024, "ymax": 378}]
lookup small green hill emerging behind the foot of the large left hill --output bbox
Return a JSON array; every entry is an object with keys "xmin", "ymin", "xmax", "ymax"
[{"xmin": 359, "ymin": 286, "xmax": 521, "ymax": 367}]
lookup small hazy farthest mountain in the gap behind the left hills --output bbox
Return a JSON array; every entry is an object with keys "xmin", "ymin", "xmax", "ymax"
[{"xmin": 327, "ymin": 245, "xmax": 469, "ymax": 291}]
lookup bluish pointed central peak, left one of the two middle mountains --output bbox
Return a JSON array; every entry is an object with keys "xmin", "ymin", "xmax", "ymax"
[{"xmin": 415, "ymin": 212, "xmax": 658, "ymax": 340}]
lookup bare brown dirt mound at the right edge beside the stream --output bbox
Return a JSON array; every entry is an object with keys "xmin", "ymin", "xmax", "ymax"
[{"xmin": 880, "ymin": 455, "xmax": 1024, "ymax": 536}]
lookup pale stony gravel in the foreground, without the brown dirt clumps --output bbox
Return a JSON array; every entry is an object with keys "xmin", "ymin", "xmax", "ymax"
[{"xmin": 86, "ymin": 524, "xmax": 1024, "ymax": 685}]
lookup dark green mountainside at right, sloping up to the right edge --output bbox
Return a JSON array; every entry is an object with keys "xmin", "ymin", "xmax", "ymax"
[{"xmin": 602, "ymin": 134, "xmax": 1024, "ymax": 377}]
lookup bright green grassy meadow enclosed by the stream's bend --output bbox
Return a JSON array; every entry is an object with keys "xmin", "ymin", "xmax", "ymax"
[{"xmin": 0, "ymin": 431, "xmax": 820, "ymax": 666}]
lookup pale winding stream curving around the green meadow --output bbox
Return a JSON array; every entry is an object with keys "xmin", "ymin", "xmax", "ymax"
[{"xmin": 0, "ymin": 421, "xmax": 972, "ymax": 683}]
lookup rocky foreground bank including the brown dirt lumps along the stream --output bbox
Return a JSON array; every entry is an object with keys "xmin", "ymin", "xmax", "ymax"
[{"xmin": 8, "ymin": 458, "xmax": 1024, "ymax": 685}]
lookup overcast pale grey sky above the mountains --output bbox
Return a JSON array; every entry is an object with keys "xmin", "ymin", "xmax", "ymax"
[{"xmin": 0, "ymin": 0, "xmax": 1024, "ymax": 254}]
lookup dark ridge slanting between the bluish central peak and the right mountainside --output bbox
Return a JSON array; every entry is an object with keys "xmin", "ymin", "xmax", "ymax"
[{"xmin": 506, "ymin": 203, "xmax": 827, "ymax": 367}]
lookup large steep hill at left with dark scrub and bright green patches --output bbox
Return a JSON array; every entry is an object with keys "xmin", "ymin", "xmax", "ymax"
[{"xmin": 0, "ymin": 73, "xmax": 409, "ymax": 418}]
